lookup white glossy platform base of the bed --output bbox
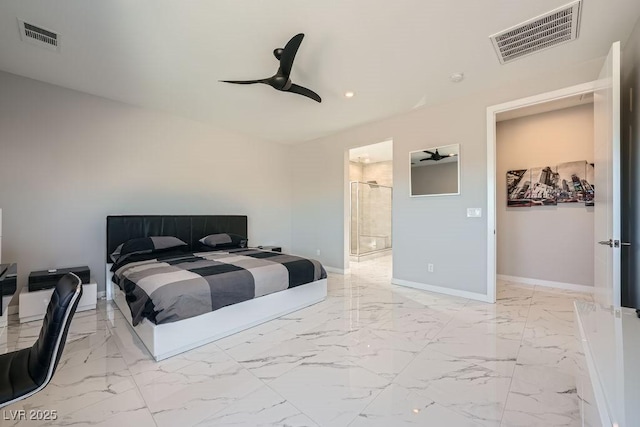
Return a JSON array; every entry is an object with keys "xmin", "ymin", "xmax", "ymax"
[{"xmin": 106, "ymin": 265, "xmax": 327, "ymax": 361}]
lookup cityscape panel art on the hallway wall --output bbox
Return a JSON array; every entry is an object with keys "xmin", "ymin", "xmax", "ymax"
[{"xmin": 507, "ymin": 160, "xmax": 595, "ymax": 207}]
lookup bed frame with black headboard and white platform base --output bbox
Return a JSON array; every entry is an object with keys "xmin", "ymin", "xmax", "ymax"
[{"xmin": 106, "ymin": 215, "xmax": 327, "ymax": 361}]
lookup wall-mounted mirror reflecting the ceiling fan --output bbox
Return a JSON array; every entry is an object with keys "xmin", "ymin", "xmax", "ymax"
[{"xmin": 410, "ymin": 144, "xmax": 460, "ymax": 197}]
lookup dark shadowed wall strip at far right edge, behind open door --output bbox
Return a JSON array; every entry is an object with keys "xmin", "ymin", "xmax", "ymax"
[{"xmin": 620, "ymin": 14, "xmax": 640, "ymax": 308}]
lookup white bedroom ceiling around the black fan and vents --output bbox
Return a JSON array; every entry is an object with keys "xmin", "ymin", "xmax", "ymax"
[{"xmin": 0, "ymin": 0, "xmax": 640, "ymax": 143}]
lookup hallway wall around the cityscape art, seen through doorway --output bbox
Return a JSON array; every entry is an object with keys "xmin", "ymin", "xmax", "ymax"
[{"xmin": 496, "ymin": 104, "xmax": 594, "ymax": 286}]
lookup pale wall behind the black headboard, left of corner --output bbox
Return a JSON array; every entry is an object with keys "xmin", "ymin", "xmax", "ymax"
[{"xmin": 0, "ymin": 72, "xmax": 291, "ymax": 296}]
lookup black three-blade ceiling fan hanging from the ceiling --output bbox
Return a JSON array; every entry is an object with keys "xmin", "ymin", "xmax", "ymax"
[{"xmin": 220, "ymin": 33, "xmax": 322, "ymax": 102}]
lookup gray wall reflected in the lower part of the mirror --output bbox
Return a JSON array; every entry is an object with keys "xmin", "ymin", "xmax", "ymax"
[{"xmin": 411, "ymin": 162, "xmax": 458, "ymax": 195}]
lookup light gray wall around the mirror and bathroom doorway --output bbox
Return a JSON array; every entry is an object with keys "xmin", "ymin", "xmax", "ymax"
[{"xmin": 292, "ymin": 58, "xmax": 602, "ymax": 294}]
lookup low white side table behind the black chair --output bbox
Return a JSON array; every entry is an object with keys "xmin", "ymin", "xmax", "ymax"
[{"xmin": 18, "ymin": 282, "xmax": 98, "ymax": 323}]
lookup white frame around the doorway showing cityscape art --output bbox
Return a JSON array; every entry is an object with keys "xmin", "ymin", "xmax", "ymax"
[{"xmin": 487, "ymin": 81, "xmax": 597, "ymax": 303}]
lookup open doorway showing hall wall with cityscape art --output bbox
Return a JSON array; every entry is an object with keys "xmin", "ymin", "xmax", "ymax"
[{"xmin": 496, "ymin": 93, "xmax": 595, "ymax": 296}]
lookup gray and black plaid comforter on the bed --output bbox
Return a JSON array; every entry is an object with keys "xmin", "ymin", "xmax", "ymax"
[{"xmin": 112, "ymin": 249, "xmax": 327, "ymax": 326}]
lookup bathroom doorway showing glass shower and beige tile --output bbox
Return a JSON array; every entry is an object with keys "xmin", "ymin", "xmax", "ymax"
[{"xmin": 346, "ymin": 140, "xmax": 393, "ymax": 262}]
